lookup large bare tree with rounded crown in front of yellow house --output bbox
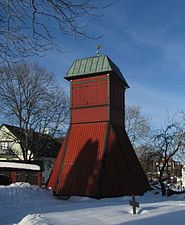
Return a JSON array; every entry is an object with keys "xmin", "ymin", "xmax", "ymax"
[{"xmin": 0, "ymin": 62, "xmax": 69, "ymax": 160}]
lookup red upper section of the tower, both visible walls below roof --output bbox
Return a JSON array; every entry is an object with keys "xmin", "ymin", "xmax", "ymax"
[{"xmin": 71, "ymin": 74, "xmax": 125, "ymax": 126}]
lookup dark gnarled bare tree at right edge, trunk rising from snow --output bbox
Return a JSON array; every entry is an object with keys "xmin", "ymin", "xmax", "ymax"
[{"xmin": 153, "ymin": 118, "xmax": 185, "ymax": 195}]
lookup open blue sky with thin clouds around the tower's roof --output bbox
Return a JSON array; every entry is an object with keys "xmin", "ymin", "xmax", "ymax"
[{"xmin": 36, "ymin": 0, "xmax": 185, "ymax": 128}]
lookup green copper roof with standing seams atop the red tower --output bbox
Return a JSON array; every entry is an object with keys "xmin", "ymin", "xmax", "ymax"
[{"xmin": 65, "ymin": 55, "xmax": 129, "ymax": 88}]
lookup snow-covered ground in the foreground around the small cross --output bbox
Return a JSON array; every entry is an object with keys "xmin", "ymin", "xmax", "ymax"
[{"xmin": 0, "ymin": 183, "xmax": 185, "ymax": 225}]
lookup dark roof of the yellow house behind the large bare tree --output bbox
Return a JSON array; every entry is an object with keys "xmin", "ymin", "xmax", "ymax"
[{"xmin": 0, "ymin": 124, "xmax": 63, "ymax": 158}]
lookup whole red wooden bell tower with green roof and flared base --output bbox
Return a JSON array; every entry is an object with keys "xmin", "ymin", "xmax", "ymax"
[{"xmin": 48, "ymin": 56, "xmax": 149, "ymax": 198}]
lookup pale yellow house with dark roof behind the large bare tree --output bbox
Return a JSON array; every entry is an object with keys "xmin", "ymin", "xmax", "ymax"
[{"xmin": 0, "ymin": 124, "xmax": 63, "ymax": 183}]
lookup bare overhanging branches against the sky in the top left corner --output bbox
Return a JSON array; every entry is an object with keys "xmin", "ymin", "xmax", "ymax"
[{"xmin": 0, "ymin": 0, "xmax": 106, "ymax": 63}]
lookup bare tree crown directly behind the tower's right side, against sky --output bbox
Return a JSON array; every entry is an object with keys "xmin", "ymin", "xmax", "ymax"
[{"xmin": 125, "ymin": 105, "xmax": 150, "ymax": 147}]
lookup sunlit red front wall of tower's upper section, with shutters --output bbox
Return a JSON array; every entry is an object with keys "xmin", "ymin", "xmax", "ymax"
[{"xmin": 71, "ymin": 74, "xmax": 109, "ymax": 124}]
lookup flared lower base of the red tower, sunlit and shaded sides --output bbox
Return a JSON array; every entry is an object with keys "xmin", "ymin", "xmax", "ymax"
[{"xmin": 48, "ymin": 122, "xmax": 149, "ymax": 198}]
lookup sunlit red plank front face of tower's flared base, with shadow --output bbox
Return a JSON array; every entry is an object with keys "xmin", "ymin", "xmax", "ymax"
[{"xmin": 57, "ymin": 123, "xmax": 106, "ymax": 197}]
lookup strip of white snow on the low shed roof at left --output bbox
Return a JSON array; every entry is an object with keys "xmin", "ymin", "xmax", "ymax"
[{"xmin": 0, "ymin": 162, "xmax": 40, "ymax": 170}]
